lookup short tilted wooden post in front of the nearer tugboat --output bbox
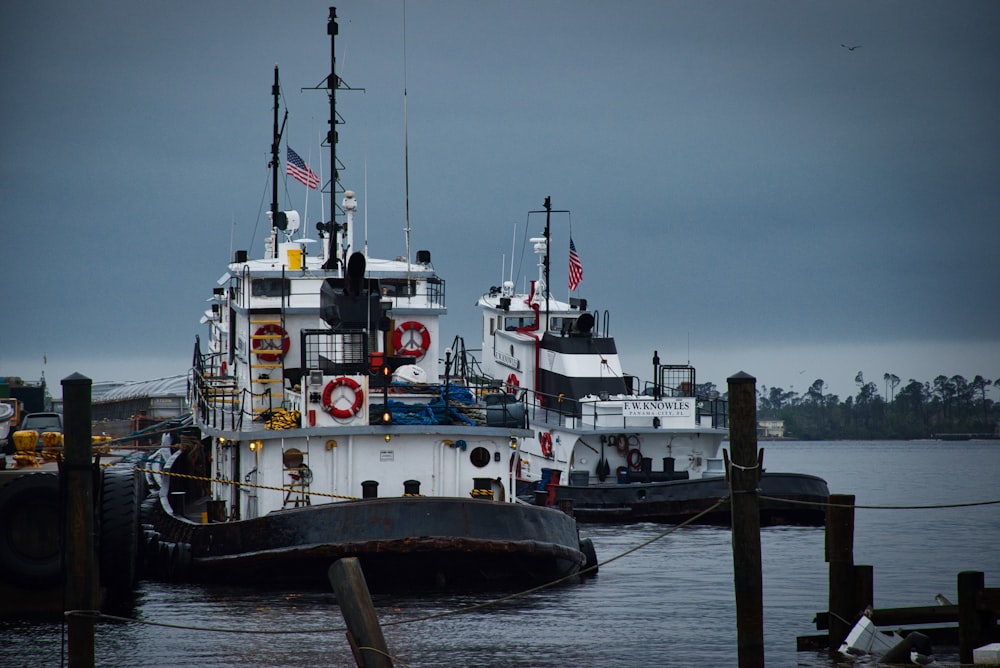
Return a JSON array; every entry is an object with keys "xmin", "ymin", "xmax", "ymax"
[{"xmin": 327, "ymin": 557, "xmax": 392, "ymax": 668}]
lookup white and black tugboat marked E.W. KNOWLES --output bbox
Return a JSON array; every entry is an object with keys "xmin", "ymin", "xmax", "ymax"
[{"xmin": 477, "ymin": 198, "xmax": 829, "ymax": 525}]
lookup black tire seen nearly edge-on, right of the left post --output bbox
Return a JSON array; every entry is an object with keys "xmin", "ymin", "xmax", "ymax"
[{"xmin": 100, "ymin": 466, "xmax": 139, "ymax": 593}]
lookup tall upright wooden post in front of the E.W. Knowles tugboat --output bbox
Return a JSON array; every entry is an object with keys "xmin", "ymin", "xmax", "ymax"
[{"xmin": 727, "ymin": 371, "xmax": 764, "ymax": 668}]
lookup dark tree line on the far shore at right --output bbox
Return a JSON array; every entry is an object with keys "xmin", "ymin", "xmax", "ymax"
[{"xmin": 744, "ymin": 371, "xmax": 1000, "ymax": 440}]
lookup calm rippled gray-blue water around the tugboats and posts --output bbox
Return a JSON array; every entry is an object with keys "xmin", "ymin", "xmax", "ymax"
[{"xmin": 0, "ymin": 441, "xmax": 1000, "ymax": 668}]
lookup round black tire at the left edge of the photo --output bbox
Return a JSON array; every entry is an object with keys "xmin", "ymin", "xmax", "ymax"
[{"xmin": 0, "ymin": 473, "xmax": 62, "ymax": 588}]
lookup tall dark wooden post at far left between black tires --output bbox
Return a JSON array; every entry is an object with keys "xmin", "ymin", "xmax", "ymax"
[{"xmin": 60, "ymin": 373, "xmax": 98, "ymax": 668}]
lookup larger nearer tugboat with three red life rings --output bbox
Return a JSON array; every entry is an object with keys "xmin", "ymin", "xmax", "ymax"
[{"xmin": 142, "ymin": 8, "xmax": 595, "ymax": 592}]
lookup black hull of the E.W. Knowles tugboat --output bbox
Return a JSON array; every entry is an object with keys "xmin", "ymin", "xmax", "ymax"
[{"xmin": 554, "ymin": 473, "xmax": 830, "ymax": 526}]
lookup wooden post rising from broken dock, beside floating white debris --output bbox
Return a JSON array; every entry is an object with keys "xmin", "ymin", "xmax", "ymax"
[{"xmin": 826, "ymin": 494, "xmax": 856, "ymax": 652}]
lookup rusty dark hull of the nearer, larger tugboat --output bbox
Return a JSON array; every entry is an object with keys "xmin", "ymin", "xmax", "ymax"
[{"xmin": 144, "ymin": 490, "xmax": 584, "ymax": 592}]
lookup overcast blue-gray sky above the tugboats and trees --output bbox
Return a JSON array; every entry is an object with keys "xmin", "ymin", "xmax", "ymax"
[{"xmin": 0, "ymin": 0, "xmax": 1000, "ymax": 399}]
